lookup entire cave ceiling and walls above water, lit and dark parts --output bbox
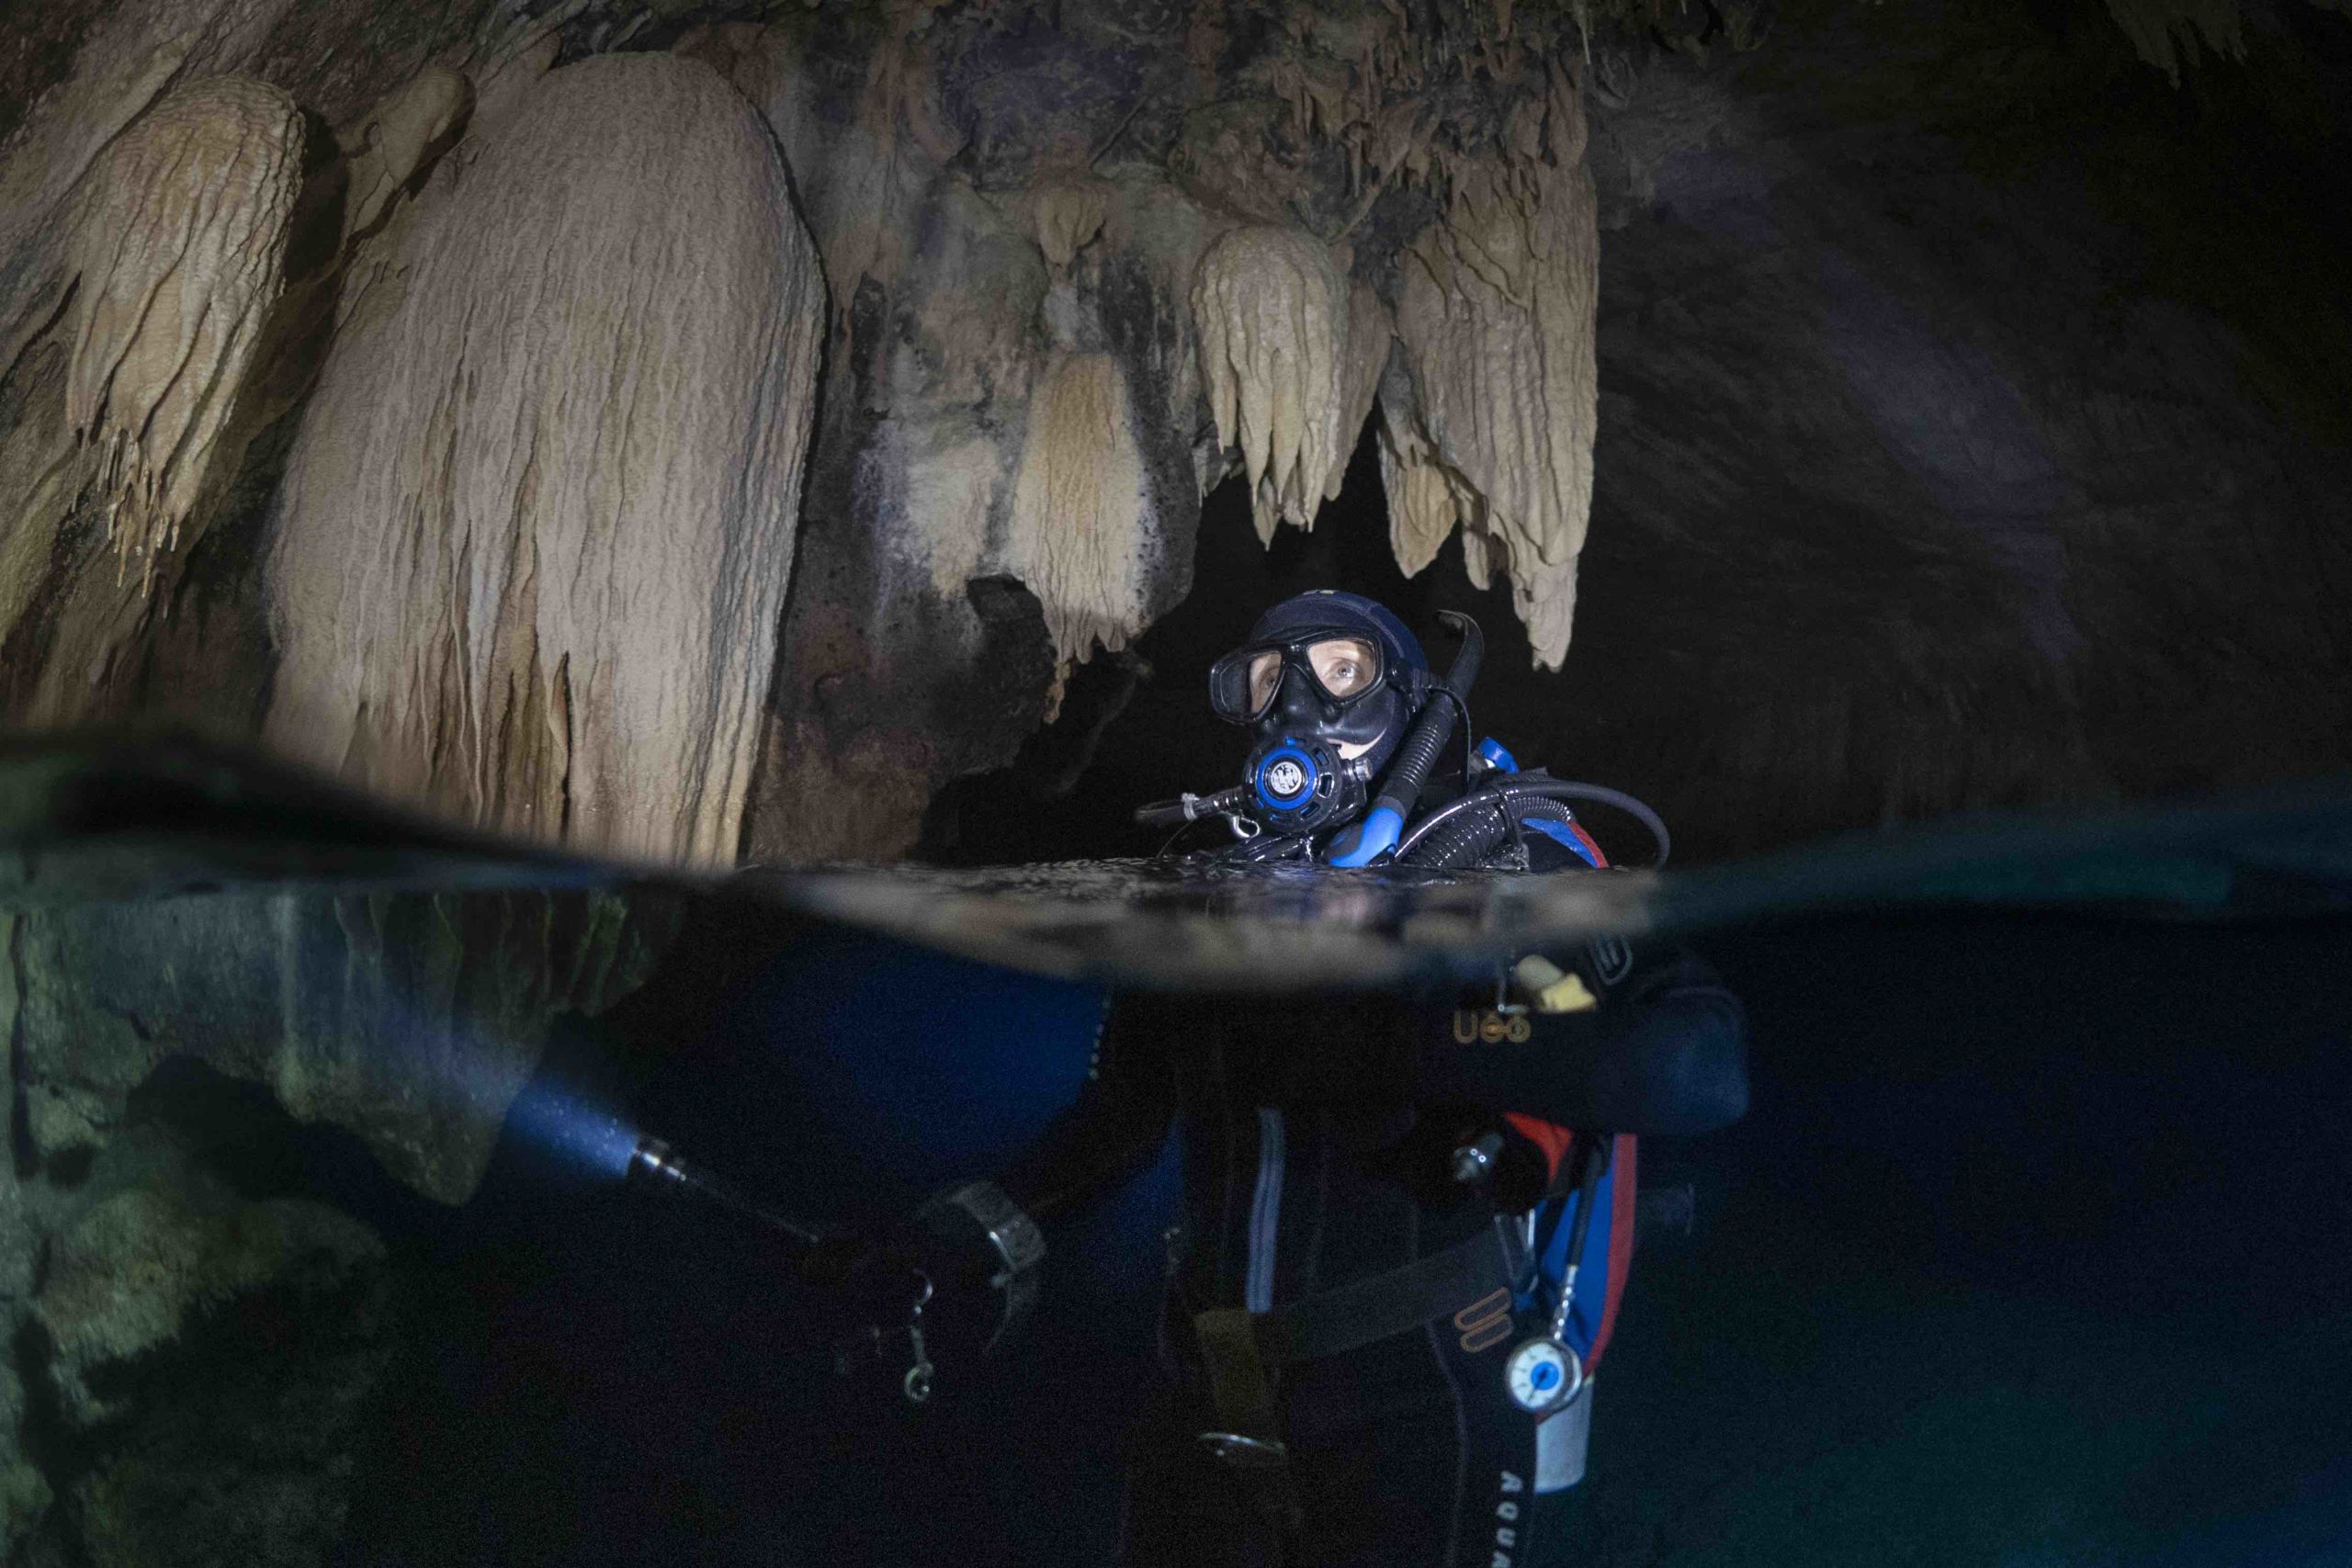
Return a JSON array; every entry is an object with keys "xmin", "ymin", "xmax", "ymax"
[{"xmin": 0, "ymin": 0, "xmax": 2347, "ymax": 865}]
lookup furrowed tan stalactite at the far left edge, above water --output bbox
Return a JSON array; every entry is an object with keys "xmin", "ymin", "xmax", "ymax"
[{"xmin": 0, "ymin": 69, "xmax": 306, "ymax": 724}]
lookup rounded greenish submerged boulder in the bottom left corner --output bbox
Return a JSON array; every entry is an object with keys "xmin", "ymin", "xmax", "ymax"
[{"xmin": 28, "ymin": 1164, "xmax": 393, "ymax": 1568}]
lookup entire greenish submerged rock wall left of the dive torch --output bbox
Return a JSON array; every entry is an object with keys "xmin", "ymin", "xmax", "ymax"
[{"xmin": 0, "ymin": 891, "xmax": 671, "ymax": 1568}]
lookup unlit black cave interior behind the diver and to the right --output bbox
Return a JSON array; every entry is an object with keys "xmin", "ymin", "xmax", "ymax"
[{"xmin": 917, "ymin": 5, "xmax": 2352, "ymax": 863}]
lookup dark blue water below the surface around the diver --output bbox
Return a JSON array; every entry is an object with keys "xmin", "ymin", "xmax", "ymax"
[{"xmin": 275, "ymin": 915, "xmax": 2352, "ymax": 1568}]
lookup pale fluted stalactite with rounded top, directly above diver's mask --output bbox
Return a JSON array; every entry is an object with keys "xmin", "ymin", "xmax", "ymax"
[{"xmin": 1193, "ymin": 226, "xmax": 1348, "ymax": 541}]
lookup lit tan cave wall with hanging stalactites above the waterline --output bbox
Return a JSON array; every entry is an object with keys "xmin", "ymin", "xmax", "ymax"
[{"xmin": 0, "ymin": 0, "xmax": 1646, "ymax": 863}]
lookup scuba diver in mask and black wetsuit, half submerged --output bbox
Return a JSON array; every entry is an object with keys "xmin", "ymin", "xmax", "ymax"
[{"xmin": 823, "ymin": 590, "xmax": 1747, "ymax": 1568}]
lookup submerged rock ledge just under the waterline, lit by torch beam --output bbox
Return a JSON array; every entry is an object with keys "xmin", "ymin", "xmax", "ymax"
[{"xmin": 7, "ymin": 894, "xmax": 663, "ymax": 1203}]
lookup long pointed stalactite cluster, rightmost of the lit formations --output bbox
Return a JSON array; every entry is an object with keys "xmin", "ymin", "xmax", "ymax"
[{"xmin": 1385, "ymin": 71, "xmax": 1600, "ymax": 668}]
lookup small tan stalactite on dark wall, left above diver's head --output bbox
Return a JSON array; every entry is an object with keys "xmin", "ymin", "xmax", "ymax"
[{"xmin": 1004, "ymin": 353, "xmax": 1155, "ymax": 660}]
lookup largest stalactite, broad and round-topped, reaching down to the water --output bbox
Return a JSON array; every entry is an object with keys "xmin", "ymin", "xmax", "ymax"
[{"xmin": 266, "ymin": 54, "xmax": 823, "ymax": 863}]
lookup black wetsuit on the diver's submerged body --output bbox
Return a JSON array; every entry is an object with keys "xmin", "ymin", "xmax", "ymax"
[{"xmin": 1002, "ymin": 950, "xmax": 1746, "ymax": 1568}]
